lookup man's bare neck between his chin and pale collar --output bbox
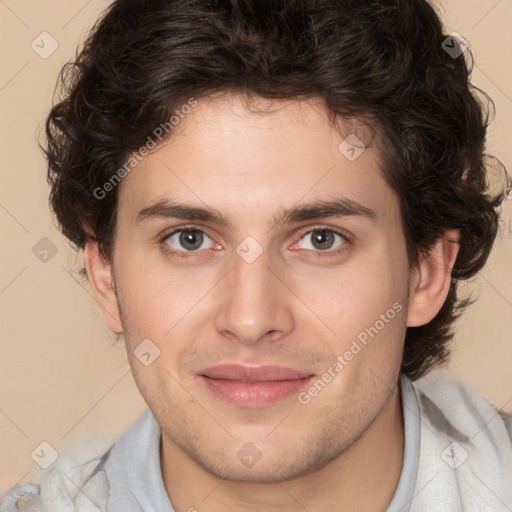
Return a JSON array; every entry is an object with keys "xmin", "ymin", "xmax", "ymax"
[{"xmin": 161, "ymin": 386, "xmax": 404, "ymax": 512}]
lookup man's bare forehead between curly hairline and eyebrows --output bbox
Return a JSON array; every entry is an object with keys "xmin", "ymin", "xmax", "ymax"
[{"xmin": 115, "ymin": 95, "xmax": 396, "ymax": 226}]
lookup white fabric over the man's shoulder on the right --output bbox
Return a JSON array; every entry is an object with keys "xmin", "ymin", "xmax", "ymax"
[{"xmin": 410, "ymin": 368, "xmax": 512, "ymax": 512}]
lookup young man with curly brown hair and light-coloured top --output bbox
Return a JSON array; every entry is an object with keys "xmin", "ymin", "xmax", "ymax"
[{"xmin": 0, "ymin": 0, "xmax": 512, "ymax": 512}]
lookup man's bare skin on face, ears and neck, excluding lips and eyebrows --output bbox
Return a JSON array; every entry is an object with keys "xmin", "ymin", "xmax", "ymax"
[{"xmin": 85, "ymin": 95, "xmax": 458, "ymax": 512}]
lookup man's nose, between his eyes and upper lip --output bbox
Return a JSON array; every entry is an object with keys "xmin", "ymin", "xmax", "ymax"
[{"xmin": 215, "ymin": 247, "xmax": 294, "ymax": 345}]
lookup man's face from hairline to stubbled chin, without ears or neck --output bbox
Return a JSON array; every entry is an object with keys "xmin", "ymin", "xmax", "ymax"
[{"xmin": 109, "ymin": 96, "xmax": 409, "ymax": 482}]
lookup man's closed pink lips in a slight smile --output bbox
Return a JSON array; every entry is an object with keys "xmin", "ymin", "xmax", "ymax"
[{"xmin": 197, "ymin": 364, "xmax": 314, "ymax": 408}]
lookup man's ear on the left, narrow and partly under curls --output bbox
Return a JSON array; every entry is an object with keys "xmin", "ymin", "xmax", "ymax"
[{"xmin": 84, "ymin": 240, "xmax": 123, "ymax": 334}]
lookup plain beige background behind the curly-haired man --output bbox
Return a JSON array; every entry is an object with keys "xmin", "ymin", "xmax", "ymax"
[{"xmin": 0, "ymin": 0, "xmax": 512, "ymax": 493}]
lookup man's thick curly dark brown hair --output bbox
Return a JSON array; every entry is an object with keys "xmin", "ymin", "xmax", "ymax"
[{"xmin": 43, "ymin": 0, "xmax": 510, "ymax": 380}]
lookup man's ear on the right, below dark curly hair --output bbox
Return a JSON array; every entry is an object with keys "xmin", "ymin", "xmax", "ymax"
[{"xmin": 407, "ymin": 229, "xmax": 460, "ymax": 327}]
